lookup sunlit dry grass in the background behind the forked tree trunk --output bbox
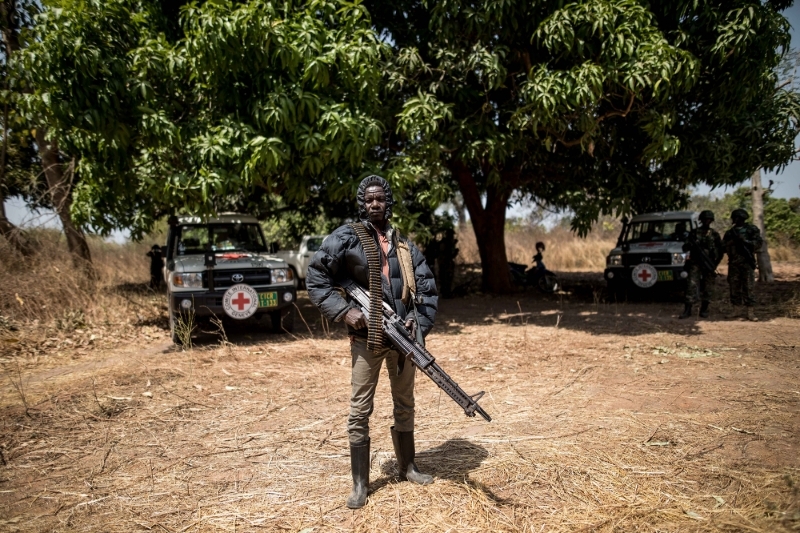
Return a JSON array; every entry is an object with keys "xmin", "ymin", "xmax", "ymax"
[{"xmin": 458, "ymin": 225, "xmax": 616, "ymax": 272}]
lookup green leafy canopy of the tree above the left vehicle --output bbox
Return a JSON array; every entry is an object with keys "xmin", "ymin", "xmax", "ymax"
[{"xmin": 23, "ymin": 0, "xmax": 385, "ymax": 236}]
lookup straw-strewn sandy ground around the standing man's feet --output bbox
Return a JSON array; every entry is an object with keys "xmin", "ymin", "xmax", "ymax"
[{"xmin": 0, "ymin": 265, "xmax": 800, "ymax": 533}]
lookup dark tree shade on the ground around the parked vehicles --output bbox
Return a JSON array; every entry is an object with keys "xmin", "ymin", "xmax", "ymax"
[{"xmin": 150, "ymin": 266, "xmax": 800, "ymax": 347}]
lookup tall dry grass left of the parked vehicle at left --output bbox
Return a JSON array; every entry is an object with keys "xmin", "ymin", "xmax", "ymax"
[{"xmin": 0, "ymin": 230, "xmax": 166, "ymax": 365}]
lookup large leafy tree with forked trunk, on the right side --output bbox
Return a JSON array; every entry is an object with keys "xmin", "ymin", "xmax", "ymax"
[{"xmin": 368, "ymin": 0, "xmax": 800, "ymax": 292}]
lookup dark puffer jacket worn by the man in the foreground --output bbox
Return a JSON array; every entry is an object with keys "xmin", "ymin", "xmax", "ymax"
[{"xmin": 306, "ymin": 223, "xmax": 439, "ymax": 337}]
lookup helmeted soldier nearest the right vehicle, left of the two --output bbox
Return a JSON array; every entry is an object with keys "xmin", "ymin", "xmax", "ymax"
[{"xmin": 678, "ymin": 210, "xmax": 725, "ymax": 318}]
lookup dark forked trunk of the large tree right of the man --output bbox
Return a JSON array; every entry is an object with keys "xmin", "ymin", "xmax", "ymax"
[{"xmin": 451, "ymin": 163, "xmax": 514, "ymax": 294}]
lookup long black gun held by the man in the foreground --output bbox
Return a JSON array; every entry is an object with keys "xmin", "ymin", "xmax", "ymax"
[{"xmin": 342, "ymin": 280, "xmax": 492, "ymax": 422}]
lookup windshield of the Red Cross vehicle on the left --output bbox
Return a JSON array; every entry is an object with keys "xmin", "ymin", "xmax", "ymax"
[{"xmin": 176, "ymin": 223, "xmax": 267, "ymax": 255}]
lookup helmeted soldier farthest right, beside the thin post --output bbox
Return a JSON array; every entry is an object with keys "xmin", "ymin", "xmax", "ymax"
[{"xmin": 722, "ymin": 209, "xmax": 763, "ymax": 321}]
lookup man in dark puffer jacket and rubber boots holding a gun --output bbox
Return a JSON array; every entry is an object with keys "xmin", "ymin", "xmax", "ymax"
[{"xmin": 306, "ymin": 176, "xmax": 438, "ymax": 509}]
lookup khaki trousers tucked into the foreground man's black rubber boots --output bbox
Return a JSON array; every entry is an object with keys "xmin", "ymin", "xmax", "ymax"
[{"xmin": 347, "ymin": 337, "xmax": 416, "ymax": 444}]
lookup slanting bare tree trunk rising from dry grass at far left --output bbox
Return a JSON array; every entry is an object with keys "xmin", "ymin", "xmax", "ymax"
[{"xmin": 36, "ymin": 128, "xmax": 96, "ymax": 279}]
